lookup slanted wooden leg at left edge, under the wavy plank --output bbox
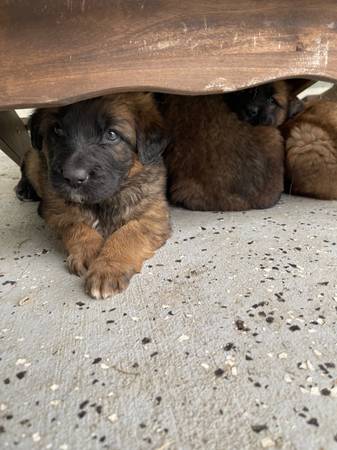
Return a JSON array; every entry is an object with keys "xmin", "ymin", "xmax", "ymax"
[{"xmin": 0, "ymin": 111, "xmax": 30, "ymax": 165}]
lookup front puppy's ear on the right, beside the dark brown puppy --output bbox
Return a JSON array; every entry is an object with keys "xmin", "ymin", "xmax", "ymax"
[{"xmin": 136, "ymin": 94, "xmax": 169, "ymax": 165}]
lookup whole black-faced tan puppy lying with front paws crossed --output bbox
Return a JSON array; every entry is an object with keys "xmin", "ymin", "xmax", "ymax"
[{"xmin": 17, "ymin": 93, "xmax": 170, "ymax": 299}]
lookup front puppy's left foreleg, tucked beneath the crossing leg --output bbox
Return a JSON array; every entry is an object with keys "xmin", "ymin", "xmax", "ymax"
[{"xmin": 41, "ymin": 192, "xmax": 103, "ymax": 276}]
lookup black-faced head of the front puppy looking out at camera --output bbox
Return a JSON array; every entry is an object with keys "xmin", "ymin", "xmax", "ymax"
[{"xmin": 30, "ymin": 93, "xmax": 167, "ymax": 204}]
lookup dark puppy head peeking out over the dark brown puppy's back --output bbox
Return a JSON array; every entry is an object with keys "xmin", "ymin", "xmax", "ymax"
[{"xmin": 224, "ymin": 81, "xmax": 303, "ymax": 127}]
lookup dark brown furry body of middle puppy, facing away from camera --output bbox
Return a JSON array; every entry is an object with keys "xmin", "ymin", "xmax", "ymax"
[{"xmin": 160, "ymin": 95, "xmax": 284, "ymax": 211}]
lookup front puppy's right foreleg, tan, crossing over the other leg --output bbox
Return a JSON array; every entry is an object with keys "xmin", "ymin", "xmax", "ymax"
[{"xmin": 85, "ymin": 202, "xmax": 170, "ymax": 299}]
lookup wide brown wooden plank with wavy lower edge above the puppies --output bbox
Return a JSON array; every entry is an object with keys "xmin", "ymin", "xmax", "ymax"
[{"xmin": 0, "ymin": 0, "xmax": 337, "ymax": 109}]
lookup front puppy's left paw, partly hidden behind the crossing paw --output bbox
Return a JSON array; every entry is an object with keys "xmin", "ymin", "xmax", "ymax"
[{"xmin": 67, "ymin": 239, "xmax": 102, "ymax": 277}]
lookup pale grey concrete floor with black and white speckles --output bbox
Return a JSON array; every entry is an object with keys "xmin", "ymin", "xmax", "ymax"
[{"xmin": 0, "ymin": 155, "xmax": 337, "ymax": 450}]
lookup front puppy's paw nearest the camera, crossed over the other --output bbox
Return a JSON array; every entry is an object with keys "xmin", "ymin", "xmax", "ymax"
[{"xmin": 85, "ymin": 258, "xmax": 136, "ymax": 299}]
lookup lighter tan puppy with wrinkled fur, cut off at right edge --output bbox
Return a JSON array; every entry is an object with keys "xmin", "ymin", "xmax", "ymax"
[{"xmin": 283, "ymin": 101, "xmax": 337, "ymax": 200}]
